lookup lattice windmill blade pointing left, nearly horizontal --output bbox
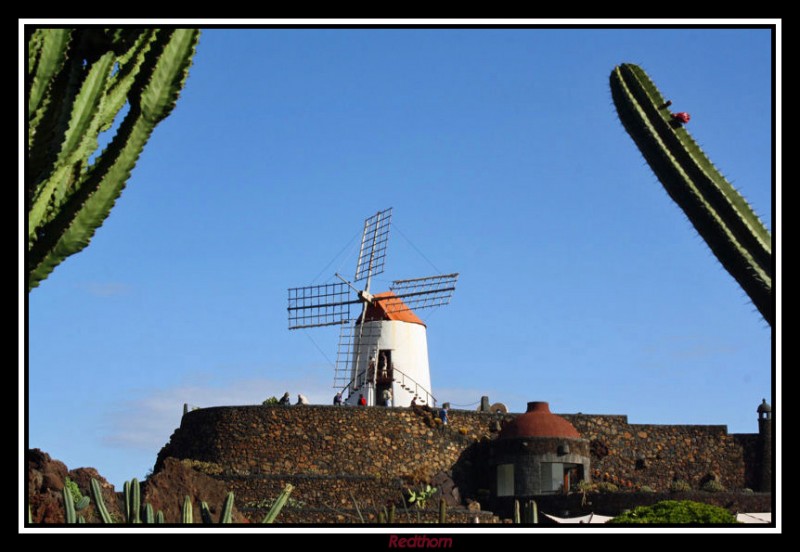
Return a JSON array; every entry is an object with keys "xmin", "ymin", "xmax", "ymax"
[{"xmin": 287, "ymin": 283, "xmax": 360, "ymax": 330}]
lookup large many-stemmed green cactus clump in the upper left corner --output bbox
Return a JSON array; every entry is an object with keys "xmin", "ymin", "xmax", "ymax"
[{"xmin": 25, "ymin": 26, "xmax": 199, "ymax": 291}]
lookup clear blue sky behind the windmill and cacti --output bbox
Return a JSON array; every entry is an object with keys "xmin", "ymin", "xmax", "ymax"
[{"xmin": 21, "ymin": 23, "xmax": 774, "ymax": 494}]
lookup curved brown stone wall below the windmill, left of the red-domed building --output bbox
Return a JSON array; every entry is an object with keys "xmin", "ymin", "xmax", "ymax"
[{"xmin": 155, "ymin": 405, "xmax": 500, "ymax": 521}]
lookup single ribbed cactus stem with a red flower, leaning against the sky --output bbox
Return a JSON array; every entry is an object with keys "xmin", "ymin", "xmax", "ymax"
[{"xmin": 610, "ymin": 63, "xmax": 775, "ymax": 325}]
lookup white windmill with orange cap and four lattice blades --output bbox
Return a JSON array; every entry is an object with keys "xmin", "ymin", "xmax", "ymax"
[{"xmin": 288, "ymin": 208, "xmax": 458, "ymax": 406}]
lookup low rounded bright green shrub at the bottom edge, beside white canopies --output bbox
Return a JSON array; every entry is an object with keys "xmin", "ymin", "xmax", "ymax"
[{"xmin": 608, "ymin": 500, "xmax": 737, "ymax": 525}]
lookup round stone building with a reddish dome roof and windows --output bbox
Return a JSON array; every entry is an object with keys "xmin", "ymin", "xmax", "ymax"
[{"xmin": 490, "ymin": 401, "xmax": 590, "ymax": 499}]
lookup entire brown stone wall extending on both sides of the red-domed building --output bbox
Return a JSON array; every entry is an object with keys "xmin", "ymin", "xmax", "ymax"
[{"xmin": 155, "ymin": 405, "xmax": 757, "ymax": 522}]
